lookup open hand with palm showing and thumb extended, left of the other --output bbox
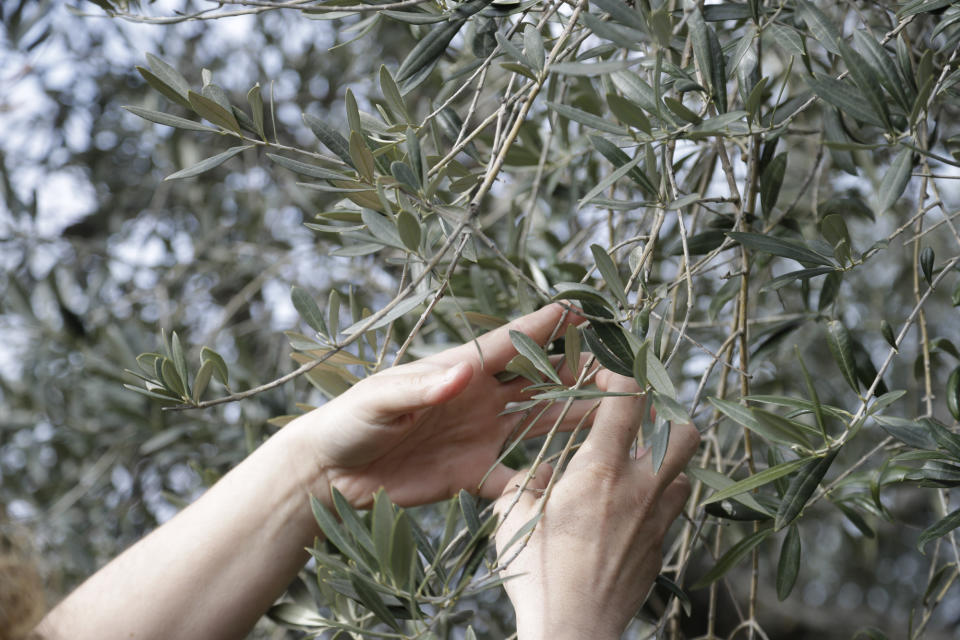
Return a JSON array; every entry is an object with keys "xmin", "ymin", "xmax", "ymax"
[{"xmin": 284, "ymin": 304, "xmax": 589, "ymax": 507}]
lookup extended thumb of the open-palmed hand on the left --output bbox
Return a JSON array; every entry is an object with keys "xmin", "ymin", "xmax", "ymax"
[{"xmin": 371, "ymin": 362, "xmax": 473, "ymax": 418}]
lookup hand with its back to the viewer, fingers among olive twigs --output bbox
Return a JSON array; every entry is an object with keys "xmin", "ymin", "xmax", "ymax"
[{"xmin": 496, "ymin": 371, "xmax": 700, "ymax": 640}]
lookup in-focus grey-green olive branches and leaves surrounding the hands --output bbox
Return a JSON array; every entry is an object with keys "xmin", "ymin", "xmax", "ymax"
[{"xmin": 5, "ymin": 0, "xmax": 960, "ymax": 637}]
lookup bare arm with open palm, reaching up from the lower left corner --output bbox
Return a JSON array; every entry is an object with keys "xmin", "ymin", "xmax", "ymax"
[{"xmin": 37, "ymin": 305, "xmax": 696, "ymax": 640}]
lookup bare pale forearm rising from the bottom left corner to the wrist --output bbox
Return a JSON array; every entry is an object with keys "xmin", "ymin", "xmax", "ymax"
[{"xmin": 39, "ymin": 425, "xmax": 329, "ymax": 640}]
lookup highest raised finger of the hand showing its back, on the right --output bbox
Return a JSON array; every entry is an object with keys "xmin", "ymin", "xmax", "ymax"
[{"xmin": 584, "ymin": 373, "xmax": 645, "ymax": 461}]
